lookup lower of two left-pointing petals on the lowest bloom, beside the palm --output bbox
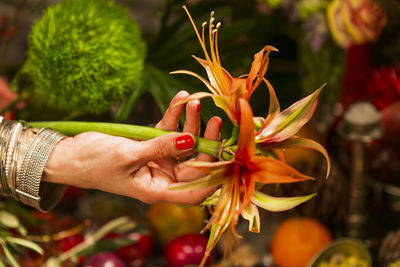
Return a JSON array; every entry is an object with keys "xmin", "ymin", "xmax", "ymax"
[{"xmin": 169, "ymin": 170, "xmax": 225, "ymax": 190}]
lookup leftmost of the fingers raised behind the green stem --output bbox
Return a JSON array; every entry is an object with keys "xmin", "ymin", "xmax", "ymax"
[{"xmin": 156, "ymin": 91, "xmax": 189, "ymax": 131}]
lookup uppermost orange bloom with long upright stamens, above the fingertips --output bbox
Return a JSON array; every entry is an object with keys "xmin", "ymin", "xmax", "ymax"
[{"xmin": 171, "ymin": 6, "xmax": 278, "ymax": 126}]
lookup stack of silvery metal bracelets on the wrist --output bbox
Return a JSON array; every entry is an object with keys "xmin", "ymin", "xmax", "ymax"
[{"xmin": 0, "ymin": 116, "xmax": 65, "ymax": 211}]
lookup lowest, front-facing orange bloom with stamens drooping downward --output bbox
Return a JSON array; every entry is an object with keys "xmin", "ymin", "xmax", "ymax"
[{"xmin": 171, "ymin": 98, "xmax": 314, "ymax": 266}]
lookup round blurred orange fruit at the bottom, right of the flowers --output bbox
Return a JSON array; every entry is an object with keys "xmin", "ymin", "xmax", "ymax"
[{"xmin": 270, "ymin": 217, "xmax": 332, "ymax": 267}]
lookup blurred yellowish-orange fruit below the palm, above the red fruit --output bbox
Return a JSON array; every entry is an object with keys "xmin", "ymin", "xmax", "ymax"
[{"xmin": 147, "ymin": 203, "xmax": 206, "ymax": 246}]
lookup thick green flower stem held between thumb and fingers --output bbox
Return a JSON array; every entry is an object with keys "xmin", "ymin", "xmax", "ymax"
[{"xmin": 29, "ymin": 121, "xmax": 233, "ymax": 160}]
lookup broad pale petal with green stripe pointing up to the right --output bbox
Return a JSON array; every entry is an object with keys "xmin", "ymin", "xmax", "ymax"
[{"xmin": 256, "ymin": 84, "xmax": 325, "ymax": 143}]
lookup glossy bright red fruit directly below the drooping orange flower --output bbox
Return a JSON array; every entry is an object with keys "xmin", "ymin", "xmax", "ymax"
[{"xmin": 165, "ymin": 234, "xmax": 212, "ymax": 267}]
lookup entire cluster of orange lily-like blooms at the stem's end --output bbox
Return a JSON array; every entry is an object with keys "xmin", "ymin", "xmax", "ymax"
[{"xmin": 171, "ymin": 7, "xmax": 330, "ymax": 266}]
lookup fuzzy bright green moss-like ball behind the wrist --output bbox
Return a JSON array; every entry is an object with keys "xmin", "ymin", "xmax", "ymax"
[{"xmin": 16, "ymin": 0, "xmax": 145, "ymax": 114}]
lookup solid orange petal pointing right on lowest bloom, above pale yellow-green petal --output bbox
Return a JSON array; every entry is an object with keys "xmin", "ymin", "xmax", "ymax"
[{"xmin": 252, "ymin": 156, "xmax": 314, "ymax": 184}]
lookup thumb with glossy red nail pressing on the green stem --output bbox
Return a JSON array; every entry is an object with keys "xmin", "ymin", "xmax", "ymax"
[{"xmin": 138, "ymin": 133, "xmax": 195, "ymax": 162}]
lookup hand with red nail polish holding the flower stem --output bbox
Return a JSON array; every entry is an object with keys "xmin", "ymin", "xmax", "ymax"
[{"xmin": 43, "ymin": 91, "xmax": 221, "ymax": 204}]
